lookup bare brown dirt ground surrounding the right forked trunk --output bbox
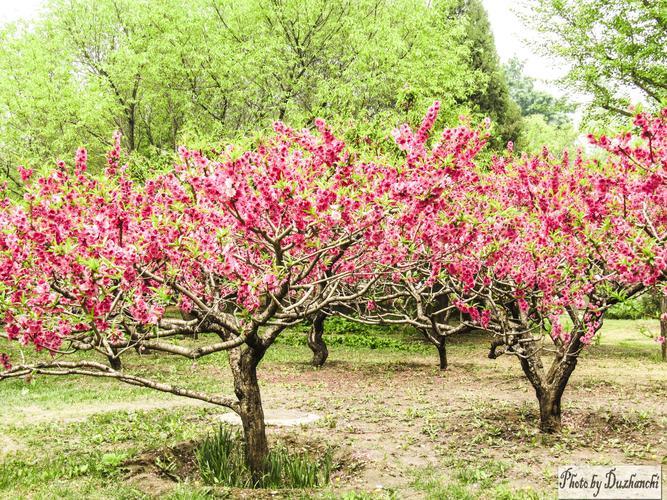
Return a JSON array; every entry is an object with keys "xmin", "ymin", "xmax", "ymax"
[{"xmin": 253, "ymin": 358, "xmax": 667, "ymax": 498}]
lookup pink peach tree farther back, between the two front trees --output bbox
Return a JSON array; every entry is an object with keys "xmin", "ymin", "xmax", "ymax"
[{"xmin": 333, "ymin": 102, "xmax": 488, "ymax": 370}]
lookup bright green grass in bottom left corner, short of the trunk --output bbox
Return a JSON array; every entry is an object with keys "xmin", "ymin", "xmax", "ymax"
[{"xmin": 0, "ymin": 408, "xmax": 211, "ymax": 498}]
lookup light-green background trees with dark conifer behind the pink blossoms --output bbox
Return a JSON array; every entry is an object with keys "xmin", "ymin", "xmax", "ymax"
[{"xmin": 0, "ymin": 0, "xmax": 520, "ymax": 186}]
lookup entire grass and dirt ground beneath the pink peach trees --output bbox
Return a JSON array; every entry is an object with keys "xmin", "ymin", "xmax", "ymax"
[{"xmin": 0, "ymin": 319, "xmax": 667, "ymax": 500}]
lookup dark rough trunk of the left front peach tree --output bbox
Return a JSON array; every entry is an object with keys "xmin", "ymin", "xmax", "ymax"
[{"xmin": 229, "ymin": 347, "xmax": 269, "ymax": 481}]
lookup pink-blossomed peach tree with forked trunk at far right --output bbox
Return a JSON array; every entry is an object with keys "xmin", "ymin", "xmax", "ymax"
[{"xmin": 444, "ymin": 112, "xmax": 667, "ymax": 432}]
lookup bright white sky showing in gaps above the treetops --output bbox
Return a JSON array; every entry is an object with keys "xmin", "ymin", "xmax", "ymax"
[{"xmin": 0, "ymin": 0, "xmax": 566, "ymax": 95}]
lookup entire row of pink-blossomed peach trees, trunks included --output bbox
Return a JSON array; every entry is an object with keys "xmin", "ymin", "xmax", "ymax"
[{"xmin": 0, "ymin": 103, "xmax": 667, "ymax": 476}]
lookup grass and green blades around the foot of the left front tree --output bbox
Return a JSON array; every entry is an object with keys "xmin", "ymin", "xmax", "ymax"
[{"xmin": 0, "ymin": 409, "xmax": 361, "ymax": 499}]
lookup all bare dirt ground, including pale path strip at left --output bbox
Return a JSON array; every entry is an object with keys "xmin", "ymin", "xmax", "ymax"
[{"xmin": 0, "ymin": 332, "xmax": 667, "ymax": 498}]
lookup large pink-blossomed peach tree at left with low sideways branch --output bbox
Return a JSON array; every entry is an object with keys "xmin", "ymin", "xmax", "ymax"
[{"xmin": 0, "ymin": 121, "xmax": 392, "ymax": 474}]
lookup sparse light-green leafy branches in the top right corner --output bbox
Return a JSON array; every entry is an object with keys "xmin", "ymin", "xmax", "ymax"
[{"xmin": 525, "ymin": 0, "xmax": 667, "ymax": 123}]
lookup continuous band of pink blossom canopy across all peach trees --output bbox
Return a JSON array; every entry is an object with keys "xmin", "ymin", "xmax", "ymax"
[{"xmin": 0, "ymin": 103, "xmax": 667, "ymax": 367}]
